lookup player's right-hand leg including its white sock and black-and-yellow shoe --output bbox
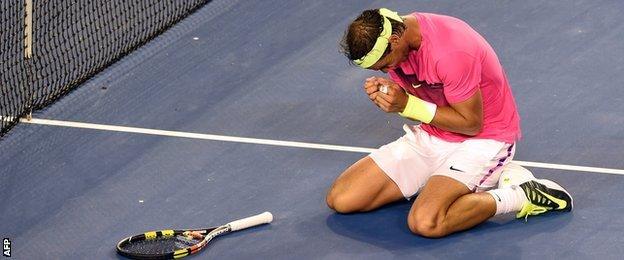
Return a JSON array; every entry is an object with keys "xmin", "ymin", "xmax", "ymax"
[{"xmin": 408, "ymin": 163, "xmax": 573, "ymax": 237}]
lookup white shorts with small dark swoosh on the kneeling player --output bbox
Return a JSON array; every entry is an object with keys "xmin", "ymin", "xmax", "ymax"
[{"xmin": 370, "ymin": 125, "xmax": 516, "ymax": 199}]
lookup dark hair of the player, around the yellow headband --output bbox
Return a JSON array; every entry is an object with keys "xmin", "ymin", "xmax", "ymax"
[{"xmin": 340, "ymin": 9, "xmax": 405, "ymax": 63}]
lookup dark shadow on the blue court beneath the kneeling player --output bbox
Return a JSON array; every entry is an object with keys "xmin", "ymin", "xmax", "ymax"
[{"xmin": 326, "ymin": 201, "xmax": 572, "ymax": 259}]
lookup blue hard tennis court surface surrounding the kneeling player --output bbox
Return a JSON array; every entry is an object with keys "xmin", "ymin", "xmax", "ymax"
[{"xmin": 0, "ymin": 0, "xmax": 624, "ymax": 259}]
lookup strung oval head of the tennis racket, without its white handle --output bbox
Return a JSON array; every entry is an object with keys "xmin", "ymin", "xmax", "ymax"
[{"xmin": 117, "ymin": 227, "xmax": 218, "ymax": 259}]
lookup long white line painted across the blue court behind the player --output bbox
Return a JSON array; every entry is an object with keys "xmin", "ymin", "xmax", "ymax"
[{"xmin": 12, "ymin": 118, "xmax": 624, "ymax": 175}]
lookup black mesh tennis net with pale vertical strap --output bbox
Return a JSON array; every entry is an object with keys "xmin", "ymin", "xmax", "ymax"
[{"xmin": 0, "ymin": 0, "xmax": 210, "ymax": 137}]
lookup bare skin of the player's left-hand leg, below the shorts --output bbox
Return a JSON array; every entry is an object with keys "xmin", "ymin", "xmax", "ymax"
[{"xmin": 326, "ymin": 156, "xmax": 404, "ymax": 213}]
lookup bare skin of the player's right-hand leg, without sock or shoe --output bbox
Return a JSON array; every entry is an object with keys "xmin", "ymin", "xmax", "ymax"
[{"xmin": 407, "ymin": 175, "xmax": 496, "ymax": 238}]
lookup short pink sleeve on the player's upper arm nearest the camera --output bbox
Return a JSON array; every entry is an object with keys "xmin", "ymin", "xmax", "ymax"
[{"xmin": 436, "ymin": 52, "xmax": 481, "ymax": 104}]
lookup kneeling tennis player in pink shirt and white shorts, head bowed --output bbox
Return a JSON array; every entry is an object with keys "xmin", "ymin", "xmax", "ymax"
[{"xmin": 327, "ymin": 8, "xmax": 572, "ymax": 237}]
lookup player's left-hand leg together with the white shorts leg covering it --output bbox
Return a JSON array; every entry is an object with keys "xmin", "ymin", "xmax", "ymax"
[{"xmin": 326, "ymin": 125, "xmax": 436, "ymax": 213}]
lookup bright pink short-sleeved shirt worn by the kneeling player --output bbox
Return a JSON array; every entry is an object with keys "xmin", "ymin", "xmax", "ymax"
[{"xmin": 388, "ymin": 13, "xmax": 521, "ymax": 143}]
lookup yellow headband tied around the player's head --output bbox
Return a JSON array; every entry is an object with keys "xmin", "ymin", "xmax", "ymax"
[{"xmin": 353, "ymin": 8, "xmax": 403, "ymax": 69}]
